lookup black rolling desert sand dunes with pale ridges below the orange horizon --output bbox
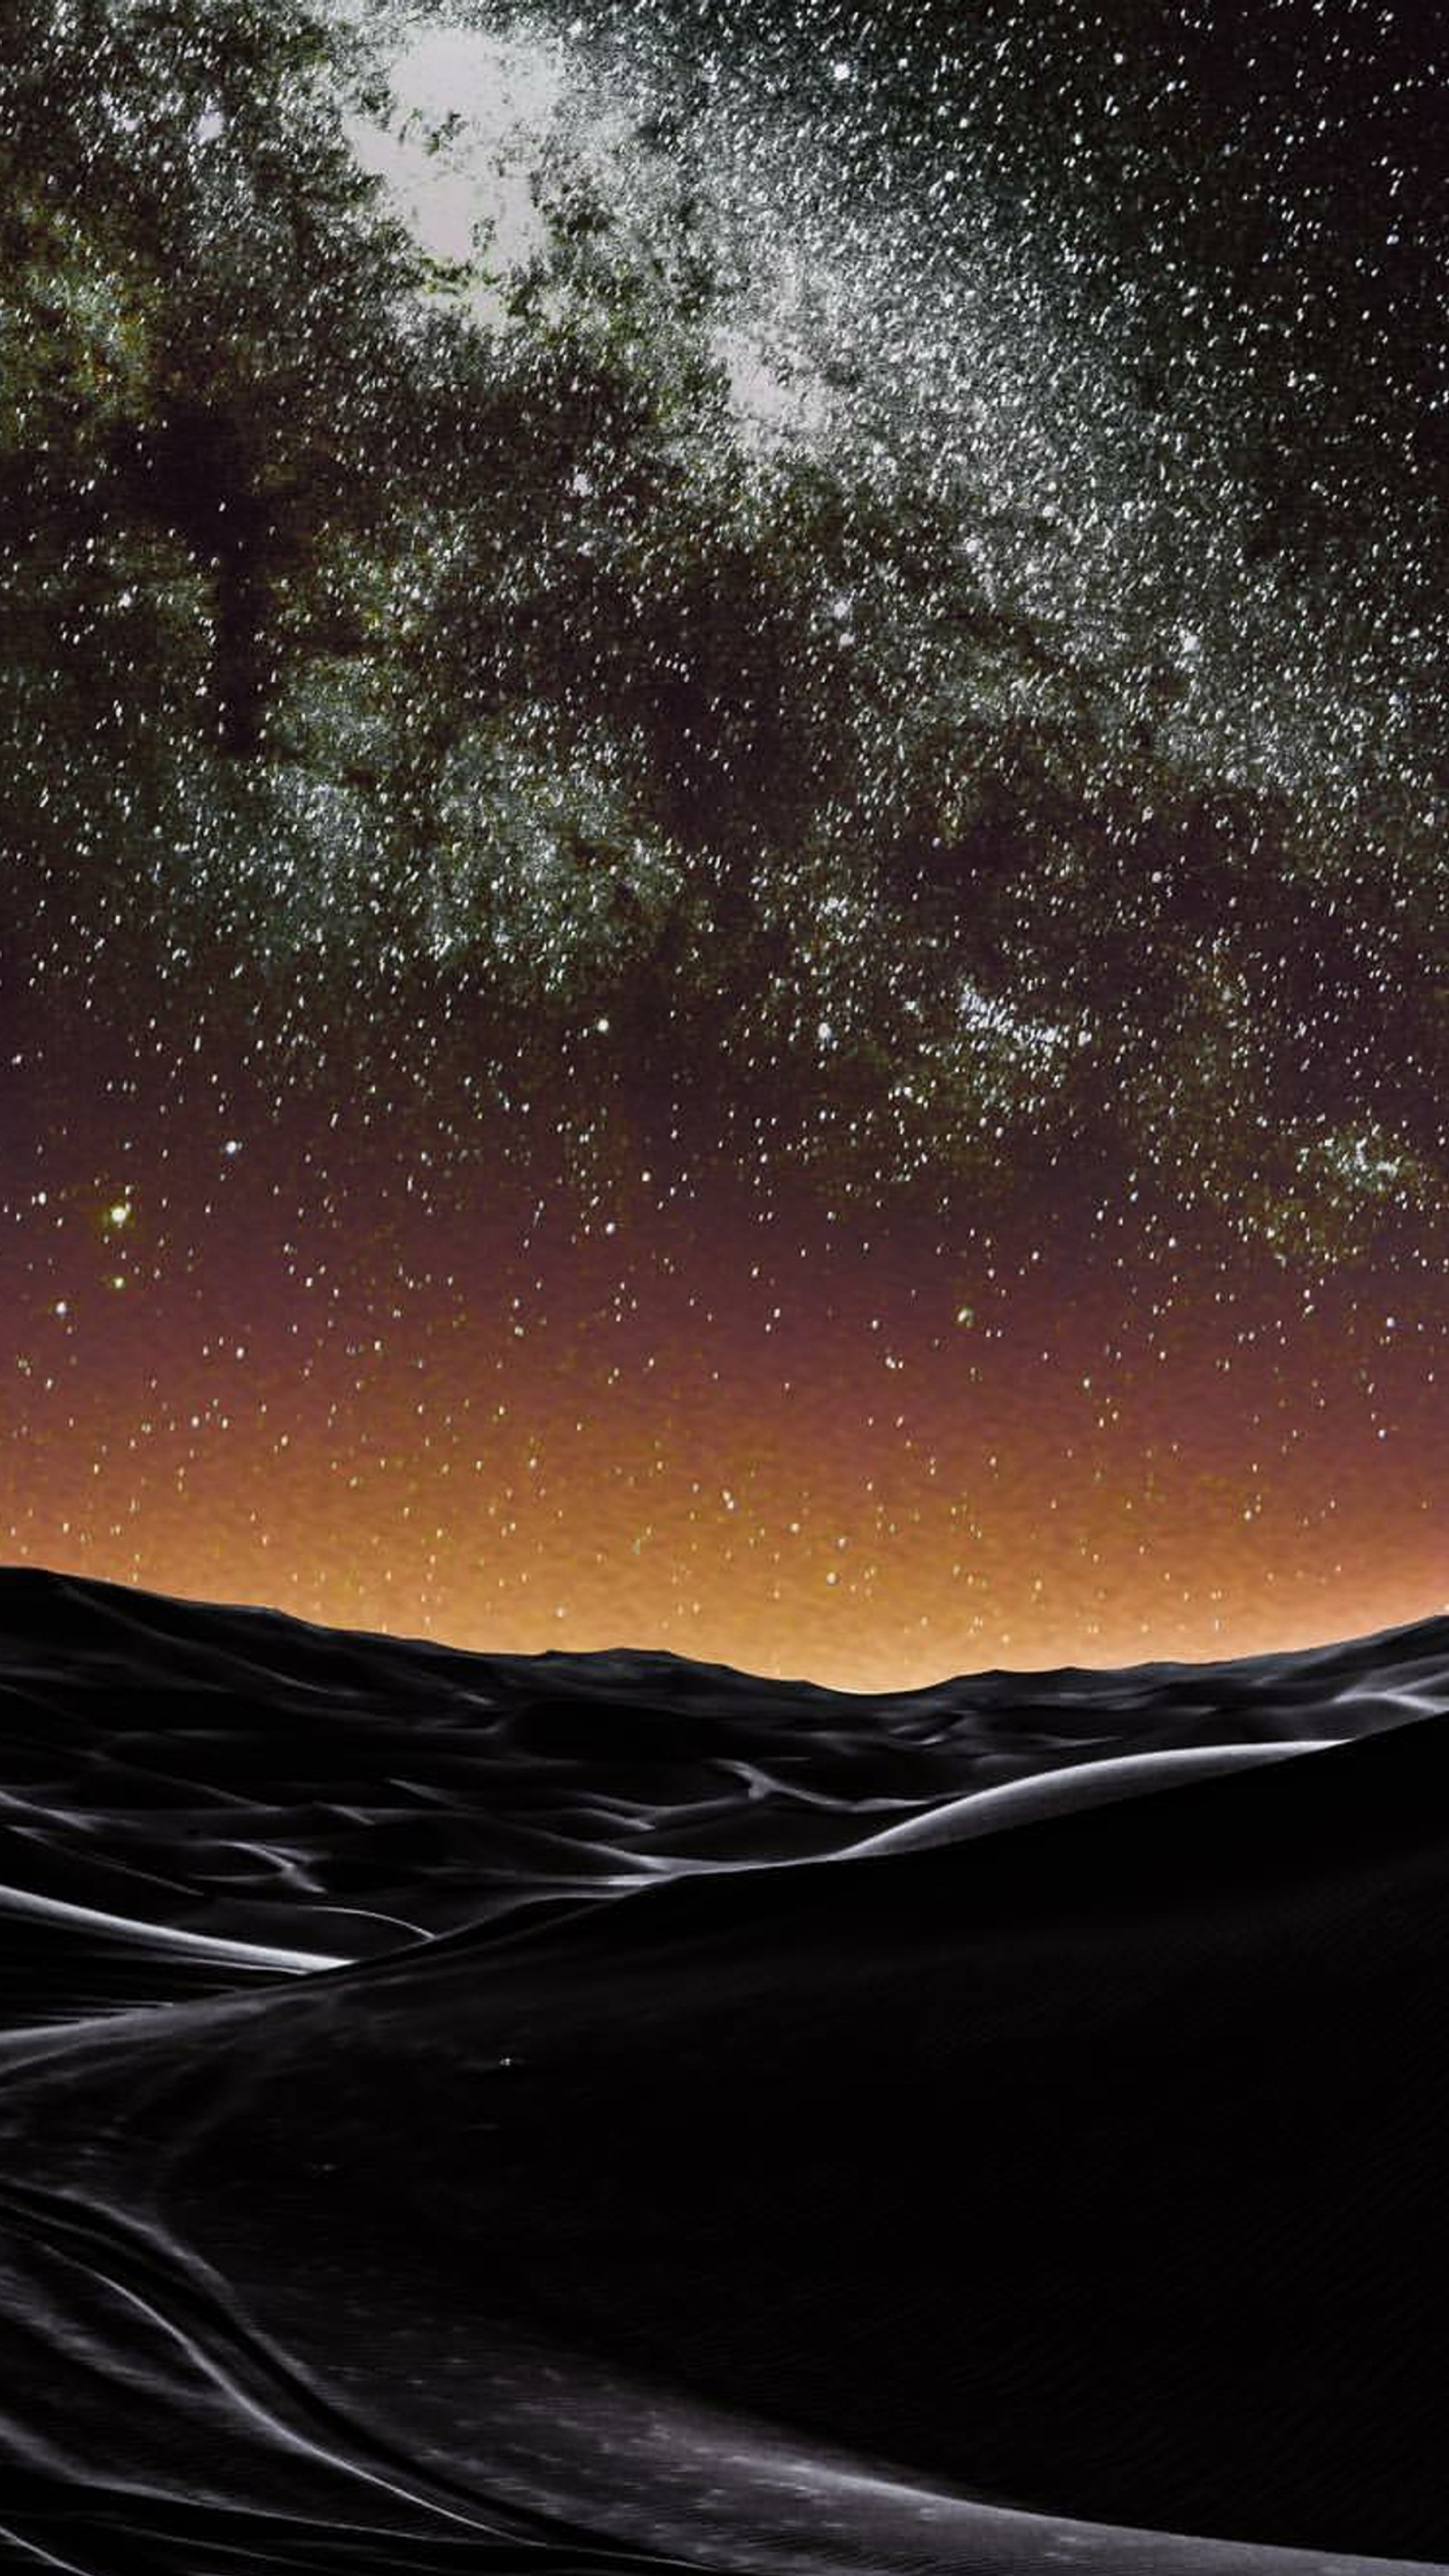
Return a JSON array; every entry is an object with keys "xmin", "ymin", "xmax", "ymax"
[{"xmin": 0, "ymin": 1572, "xmax": 1449, "ymax": 2576}]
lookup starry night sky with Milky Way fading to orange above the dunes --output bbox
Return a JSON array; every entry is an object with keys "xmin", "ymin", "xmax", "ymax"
[{"xmin": 0, "ymin": 0, "xmax": 1449, "ymax": 1687}]
